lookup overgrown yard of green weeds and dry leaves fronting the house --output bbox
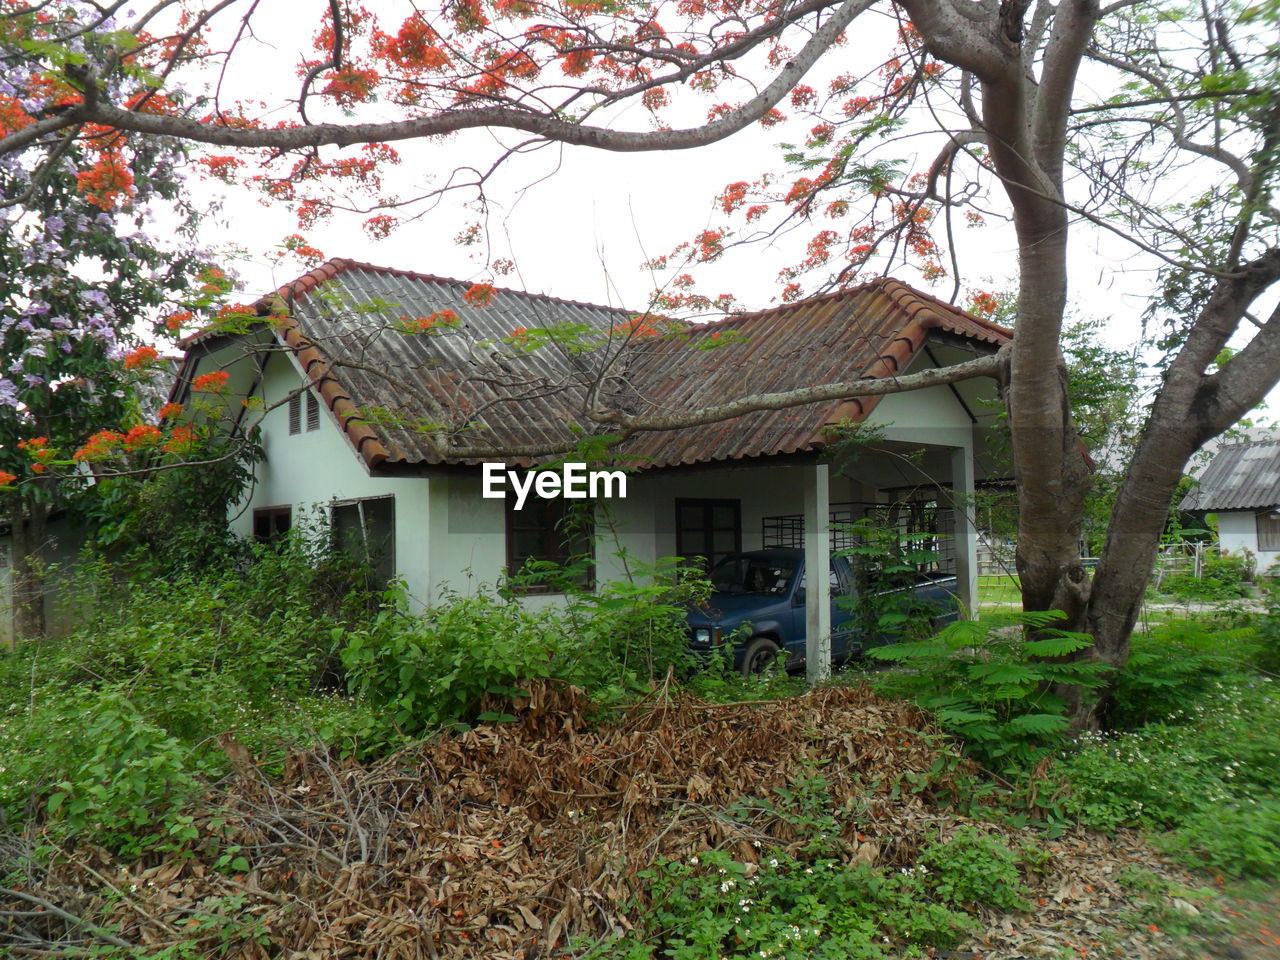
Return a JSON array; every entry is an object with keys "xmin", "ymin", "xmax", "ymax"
[{"xmin": 0, "ymin": 540, "xmax": 1280, "ymax": 960}]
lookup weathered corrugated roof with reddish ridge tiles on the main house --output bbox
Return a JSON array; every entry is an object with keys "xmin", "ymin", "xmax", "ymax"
[{"xmin": 192, "ymin": 260, "xmax": 1011, "ymax": 468}]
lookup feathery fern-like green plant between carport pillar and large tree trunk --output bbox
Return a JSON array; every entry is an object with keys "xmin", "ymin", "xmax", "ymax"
[{"xmin": 870, "ymin": 612, "xmax": 1105, "ymax": 767}]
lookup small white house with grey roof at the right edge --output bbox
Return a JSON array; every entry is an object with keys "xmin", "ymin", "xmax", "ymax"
[{"xmin": 1178, "ymin": 439, "xmax": 1280, "ymax": 572}]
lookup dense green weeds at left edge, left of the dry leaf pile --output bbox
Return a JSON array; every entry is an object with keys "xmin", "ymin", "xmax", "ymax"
[{"xmin": 0, "ymin": 543, "xmax": 394, "ymax": 854}]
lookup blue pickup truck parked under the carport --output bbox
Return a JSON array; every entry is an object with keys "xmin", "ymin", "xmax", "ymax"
[{"xmin": 687, "ymin": 548, "xmax": 957, "ymax": 675}]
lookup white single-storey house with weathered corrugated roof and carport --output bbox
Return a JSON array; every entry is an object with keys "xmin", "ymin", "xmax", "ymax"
[{"xmin": 173, "ymin": 260, "xmax": 1011, "ymax": 619}]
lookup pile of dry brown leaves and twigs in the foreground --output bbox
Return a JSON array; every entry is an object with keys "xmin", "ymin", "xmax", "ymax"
[{"xmin": 0, "ymin": 685, "xmax": 1198, "ymax": 960}]
